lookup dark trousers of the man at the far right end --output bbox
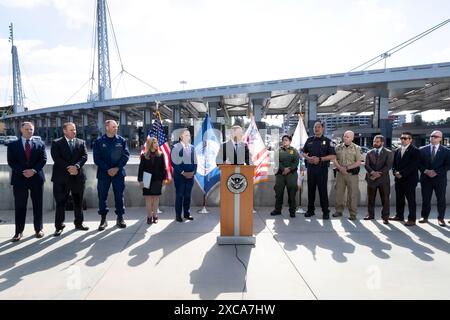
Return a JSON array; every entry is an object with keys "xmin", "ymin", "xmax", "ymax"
[{"xmin": 420, "ymin": 177, "xmax": 447, "ymax": 220}]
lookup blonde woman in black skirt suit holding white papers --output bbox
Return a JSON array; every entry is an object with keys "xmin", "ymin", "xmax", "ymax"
[{"xmin": 138, "ymin": 137, "xmax": 166, "ymax": 224}]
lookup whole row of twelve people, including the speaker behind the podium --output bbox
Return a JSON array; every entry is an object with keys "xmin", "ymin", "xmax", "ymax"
[{"xmin": 7, "ymin": 120, "xmax": 450, "ymax": 242}]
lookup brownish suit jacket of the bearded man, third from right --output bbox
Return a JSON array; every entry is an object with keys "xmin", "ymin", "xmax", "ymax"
[{"xmin": 364, "ymin": 148, "xmax": 392, "ymax": 187}]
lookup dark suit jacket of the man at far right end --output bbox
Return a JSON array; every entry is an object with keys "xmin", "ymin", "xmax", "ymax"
[{"xmin": 419, "ymin": 145, "xmax": 450, "ymax": 181}]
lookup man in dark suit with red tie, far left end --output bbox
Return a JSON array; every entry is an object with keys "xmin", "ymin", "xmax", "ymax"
[{"xmin": 7, "ymin": 122, "xmax": 47, "ymax": 242}]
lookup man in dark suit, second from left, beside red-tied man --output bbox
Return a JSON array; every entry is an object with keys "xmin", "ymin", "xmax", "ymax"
[{"xmin": 51, "ymin": 122, "xmax": 89, "ymax": 236}]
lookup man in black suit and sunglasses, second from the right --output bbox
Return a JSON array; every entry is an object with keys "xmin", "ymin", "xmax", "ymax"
[{"xmin": 389, "ymin": 132, "xmax": 420, "ymax": 227}]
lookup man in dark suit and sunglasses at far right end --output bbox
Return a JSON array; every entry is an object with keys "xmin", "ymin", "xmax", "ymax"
[{"xmin": 419, "ymin": 131, "xmax": 450, "ymax": 227}]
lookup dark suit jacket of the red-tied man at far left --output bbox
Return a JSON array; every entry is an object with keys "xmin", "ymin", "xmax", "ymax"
[{"xmin": 7, "ymin": 139, "xmax": 47, "ymax": 187}]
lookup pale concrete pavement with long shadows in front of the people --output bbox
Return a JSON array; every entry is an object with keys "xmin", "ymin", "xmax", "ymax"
[{"xmin": 0, "ymin": 207, "xmax": 450, "ymax": 300}]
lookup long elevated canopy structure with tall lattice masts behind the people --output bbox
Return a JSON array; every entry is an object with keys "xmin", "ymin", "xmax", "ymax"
[{"xmin": 0, "ymin": 0, "xmax": 450, "ymax": 148}]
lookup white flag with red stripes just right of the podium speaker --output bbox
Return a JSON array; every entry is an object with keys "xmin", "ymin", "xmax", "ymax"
[{"xmin": 243, "ymin": 116, "xmax": 269, "ymax": 184}]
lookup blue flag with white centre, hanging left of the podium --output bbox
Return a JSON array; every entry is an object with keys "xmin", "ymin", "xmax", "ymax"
[{"xmin": 194, "ymin": 114, "xmax": 220, "ymax": 194}]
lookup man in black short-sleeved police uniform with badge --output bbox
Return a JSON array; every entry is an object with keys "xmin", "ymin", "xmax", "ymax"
[{"xmin": 303, "ymin": 121, "xmax": 336, "ymax": 220}]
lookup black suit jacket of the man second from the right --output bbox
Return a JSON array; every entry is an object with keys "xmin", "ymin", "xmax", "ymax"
[{"xmin": 392, "ymin": 144, "xmax": 420, "ymax": 185}]
